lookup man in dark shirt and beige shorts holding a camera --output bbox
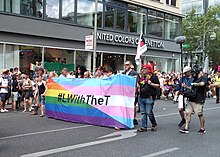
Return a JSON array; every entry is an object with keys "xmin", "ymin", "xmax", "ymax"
[{"xmin": 179, "ymin": 70, "xmax": 207, "ymax": 134}]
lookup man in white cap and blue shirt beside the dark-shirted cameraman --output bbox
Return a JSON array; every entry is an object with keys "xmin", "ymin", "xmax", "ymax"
[{"xmin": 175, "ymin": 66, "xmax": 193, "ymax": 127}]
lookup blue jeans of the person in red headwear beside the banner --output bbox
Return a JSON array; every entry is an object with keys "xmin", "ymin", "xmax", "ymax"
[{"xmin": 138, "ymin": 98, "xmax": 157, "ymax": 128}]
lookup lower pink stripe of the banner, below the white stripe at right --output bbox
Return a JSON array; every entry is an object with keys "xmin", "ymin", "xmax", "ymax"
[{"xmin": 94, "ymin": 106, "xmax": 134, "ymax": 119}]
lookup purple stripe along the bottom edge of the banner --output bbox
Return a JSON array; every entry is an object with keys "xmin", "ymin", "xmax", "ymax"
[{"xmin": 46, "ymin": 110, "xmax": 128, "ymax": 129}]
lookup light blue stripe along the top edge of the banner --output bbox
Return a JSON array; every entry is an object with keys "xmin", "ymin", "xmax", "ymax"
[{"xmin": 53, "ymin": 74, "xmax": 136, "ymax": 87}]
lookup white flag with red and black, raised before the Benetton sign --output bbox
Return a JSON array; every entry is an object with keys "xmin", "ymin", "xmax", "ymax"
[{"xmin": 135, "ymin": 33, "xmax": 147, "ymax": 65}]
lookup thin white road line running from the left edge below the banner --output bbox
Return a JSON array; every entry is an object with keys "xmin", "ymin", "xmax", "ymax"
[{"xmin": 0, "ymin": 125, "xmax": 91, "ymax": 140}]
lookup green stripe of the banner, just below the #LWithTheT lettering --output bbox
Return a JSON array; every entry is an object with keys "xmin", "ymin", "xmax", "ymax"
[{"xmin": 46, "ymin": 96, "xmax": 93, "ymax": 108}]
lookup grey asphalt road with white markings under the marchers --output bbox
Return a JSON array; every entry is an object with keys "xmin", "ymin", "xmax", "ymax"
[{"xmin": 0, "ymin": 99, "xmax": 220, "ymax": 157}]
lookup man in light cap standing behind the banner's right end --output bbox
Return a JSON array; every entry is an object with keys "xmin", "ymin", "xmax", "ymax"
[{"xmin": 122, "ymin": 61, "xmax": 138, "ymax": 125}]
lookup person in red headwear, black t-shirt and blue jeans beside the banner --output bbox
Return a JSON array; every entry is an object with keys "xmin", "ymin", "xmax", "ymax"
[{"xmin": 137, "ymin": 64, "xmax": 160, "ymax": 132}]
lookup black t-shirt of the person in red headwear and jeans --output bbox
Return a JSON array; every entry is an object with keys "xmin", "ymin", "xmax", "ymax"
[{"xmin": 137, "ymin": 74, "xmax": 160, "ymax": 98}]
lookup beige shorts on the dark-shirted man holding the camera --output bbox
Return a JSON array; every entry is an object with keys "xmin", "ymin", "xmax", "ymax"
[{"xmin": 186, "ymin": 101, "xmax": 204, "ymax": 116}]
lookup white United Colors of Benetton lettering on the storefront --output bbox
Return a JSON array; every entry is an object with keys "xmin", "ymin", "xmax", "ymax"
[{"xmin": 97, "ymin": 33, "xmax": 164, "ymax": 48}]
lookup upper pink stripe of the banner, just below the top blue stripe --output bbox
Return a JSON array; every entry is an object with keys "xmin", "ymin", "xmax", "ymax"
[{"xmin": 62, "ymin": 85, "xmax": 135, "ymax": 98}]
